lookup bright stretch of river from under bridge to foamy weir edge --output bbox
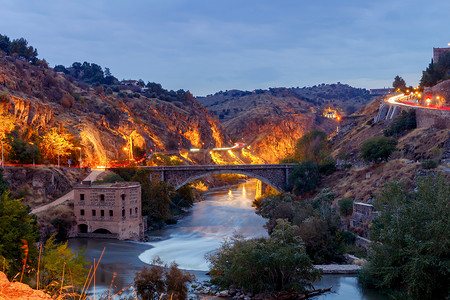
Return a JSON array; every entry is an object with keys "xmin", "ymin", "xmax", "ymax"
[{"xmin": 139, "ymin": 182, "xmax": 267, "ymax": 271}]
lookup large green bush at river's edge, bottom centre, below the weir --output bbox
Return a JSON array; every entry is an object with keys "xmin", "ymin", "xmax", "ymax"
[{"xmin": 207, "ymin": 220, "xmax": 319, "ymax": 293}]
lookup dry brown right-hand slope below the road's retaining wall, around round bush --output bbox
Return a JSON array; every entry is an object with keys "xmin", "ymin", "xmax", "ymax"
[{"xmin": 322, "ymin": 95, "xmax": 450, "ymax": 202}]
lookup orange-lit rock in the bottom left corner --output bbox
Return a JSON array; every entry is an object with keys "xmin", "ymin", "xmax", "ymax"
[{"xmin": 0, "ymin": 272, "xmax": 52, "ymax": 300}]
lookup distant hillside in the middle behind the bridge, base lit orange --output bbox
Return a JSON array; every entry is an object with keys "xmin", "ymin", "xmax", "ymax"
[{"xmin": 199, "ymin": 83, "xmax": 374, "ymax": 163}]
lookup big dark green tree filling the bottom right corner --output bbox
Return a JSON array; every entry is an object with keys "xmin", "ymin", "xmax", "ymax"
[{"xmin": 359, "ymin": 174, "xmax": 450, "ymax": 299}]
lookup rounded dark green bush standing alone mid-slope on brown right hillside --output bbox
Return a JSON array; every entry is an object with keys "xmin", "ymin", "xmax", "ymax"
[{"xmin": 360, "ymin": 136, "xmax": 397, "ymax": 163}]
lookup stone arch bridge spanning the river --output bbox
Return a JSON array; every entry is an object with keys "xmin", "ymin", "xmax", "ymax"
[{"xmin": 141, "ymin": 164, "xmax": 295, "ymax": 192}]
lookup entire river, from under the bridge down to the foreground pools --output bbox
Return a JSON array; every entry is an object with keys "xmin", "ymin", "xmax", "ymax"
[{"xmin": 69, "ymin": 180, "xmax": 384, "ymax": 300}]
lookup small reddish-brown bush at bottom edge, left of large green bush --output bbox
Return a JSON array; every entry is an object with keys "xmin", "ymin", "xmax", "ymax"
[{"xmin": 134, "ymin": 258, "xmax": 195, "ymax": 300}]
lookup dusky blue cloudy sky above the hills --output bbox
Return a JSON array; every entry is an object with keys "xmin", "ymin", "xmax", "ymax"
[{"xmin": 0, "ymin": 0, "xmax": 450, "ymax": 95}]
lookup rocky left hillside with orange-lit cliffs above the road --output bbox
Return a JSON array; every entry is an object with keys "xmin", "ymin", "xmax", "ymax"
[{"xmin": 0, "ymin": 51, "xmax": 231, "ymax": 166}]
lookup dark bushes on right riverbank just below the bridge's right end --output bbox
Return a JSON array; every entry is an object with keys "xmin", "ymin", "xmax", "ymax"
[{"xmin": 256, "ymin": 189, "xmax": 345, "ymax": 264}]
